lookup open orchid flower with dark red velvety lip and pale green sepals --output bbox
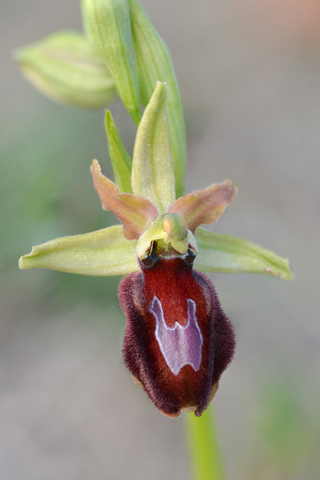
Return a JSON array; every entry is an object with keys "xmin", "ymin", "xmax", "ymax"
[{"xmin": 19, "ymin": 82, "xmax": 291, "ymax": 417}]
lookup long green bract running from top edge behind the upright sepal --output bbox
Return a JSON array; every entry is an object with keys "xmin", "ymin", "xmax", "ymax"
[{"xmin": 129, "ymin": 0, "xmax": 187, "ymax": 197}]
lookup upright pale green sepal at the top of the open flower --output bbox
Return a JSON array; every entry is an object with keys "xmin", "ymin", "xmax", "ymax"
[{"xmin": 131, "ymin": 82, "xmax": 175, "ymax": 213}]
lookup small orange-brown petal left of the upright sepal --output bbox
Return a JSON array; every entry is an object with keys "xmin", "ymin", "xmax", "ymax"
[{"xmin": 91, "ymin": 160, "xmax": 158, "ymax": 240}]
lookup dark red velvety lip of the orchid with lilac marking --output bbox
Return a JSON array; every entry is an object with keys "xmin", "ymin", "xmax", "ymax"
[{"xmin": 119, "ymin": 241, "xmax": 235, "ymax": 417}]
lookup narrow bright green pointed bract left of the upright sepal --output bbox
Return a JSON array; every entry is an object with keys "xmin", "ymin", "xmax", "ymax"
[{"xmin": 104, "ymin": 110, "xmax": 132, "ymax": 193}]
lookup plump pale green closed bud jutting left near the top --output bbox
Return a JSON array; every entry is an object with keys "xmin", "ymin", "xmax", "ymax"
[{"xmin": 15, "ymin": 31, "xmax": 117, "ymax": 108}]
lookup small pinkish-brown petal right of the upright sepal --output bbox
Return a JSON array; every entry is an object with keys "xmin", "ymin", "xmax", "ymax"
[{"xmin": 169, "ymin": 180, "xmax": 237, "ymax": 233}]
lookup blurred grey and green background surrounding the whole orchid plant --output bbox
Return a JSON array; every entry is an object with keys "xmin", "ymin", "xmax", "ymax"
[{"xmin": 0, "ymin": 0, "xmax": 320, "ymax": 480}]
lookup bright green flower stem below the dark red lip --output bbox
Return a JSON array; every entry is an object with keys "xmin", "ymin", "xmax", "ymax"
[{"xmin": 186, "ymin": 407, "xmax": 226, "ymax": 480}]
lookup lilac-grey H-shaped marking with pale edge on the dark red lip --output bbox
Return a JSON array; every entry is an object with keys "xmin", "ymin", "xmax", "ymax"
[{"xmin": 150, "ymin": 296, "xmax": 203, "ymax": 375}]
